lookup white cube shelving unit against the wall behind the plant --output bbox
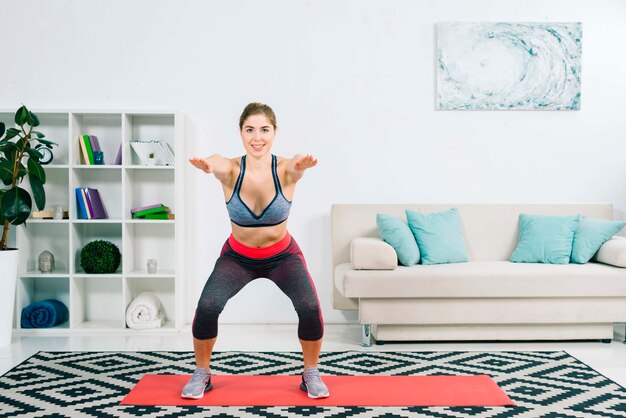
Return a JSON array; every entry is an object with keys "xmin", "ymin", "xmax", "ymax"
[{"xmin": 0, "ymin": 109, "xmax": 185, "ymax": 334}]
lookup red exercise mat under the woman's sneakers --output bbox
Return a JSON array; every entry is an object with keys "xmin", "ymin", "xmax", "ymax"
[{"xmin": 121, "ymin": 374, "xmax": 515, "ymax": 406}]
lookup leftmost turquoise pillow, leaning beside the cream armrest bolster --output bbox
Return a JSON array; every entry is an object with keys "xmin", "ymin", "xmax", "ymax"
[{"xmin": 376, "ymin": 213, "xmax": 420, "ymax": 266}]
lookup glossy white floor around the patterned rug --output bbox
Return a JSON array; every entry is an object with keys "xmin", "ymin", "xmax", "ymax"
[{"xmin": 0, "ymin": 324, "xmax": 626, "ymax": 387}]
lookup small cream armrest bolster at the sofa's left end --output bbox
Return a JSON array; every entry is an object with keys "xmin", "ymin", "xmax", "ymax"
[{"xmin": 350, "ymin": 237, "xmax": 398, "ymax": 270}]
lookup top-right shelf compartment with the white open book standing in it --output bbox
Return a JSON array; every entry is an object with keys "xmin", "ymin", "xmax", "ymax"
[{"xmin": 123, "ymin": 113, "xmax": 176, "ymax": 167}]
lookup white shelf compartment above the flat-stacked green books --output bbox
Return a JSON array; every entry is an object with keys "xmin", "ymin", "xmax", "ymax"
[{"xmin": 124, "ymin": 169, "xmax": 176, "ymax": 220}]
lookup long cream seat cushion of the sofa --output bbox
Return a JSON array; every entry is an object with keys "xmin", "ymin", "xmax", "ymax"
[{"xmin": 335, "ymin": 260, "xmax": 626, "ymax": 298}]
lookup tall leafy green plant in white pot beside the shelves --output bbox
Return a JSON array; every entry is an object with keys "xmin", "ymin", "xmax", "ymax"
[{"xmin": 0, "ymin": 106, "xmax": 57, "ymax": 346}]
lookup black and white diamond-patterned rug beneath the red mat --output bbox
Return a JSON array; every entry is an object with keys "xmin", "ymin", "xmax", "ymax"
[{"xmin": 0, "ymin": 351, "xmax": 626, "ymax": 418}]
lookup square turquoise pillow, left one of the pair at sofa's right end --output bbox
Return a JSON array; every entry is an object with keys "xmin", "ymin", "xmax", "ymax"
[{"xmin": 509, "ymin": 214, "xmax": 580, "ymax": 264}]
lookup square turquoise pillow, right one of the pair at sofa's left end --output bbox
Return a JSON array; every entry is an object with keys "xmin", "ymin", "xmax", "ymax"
[{"xmin": 406, "ymin": 208, "xmax": 467, "ymax": 264}]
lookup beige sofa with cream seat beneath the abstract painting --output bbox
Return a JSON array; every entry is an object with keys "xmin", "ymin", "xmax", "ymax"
[{"xmin": 331, "ymin": 204, "xmax": 626, "ymax": 345}]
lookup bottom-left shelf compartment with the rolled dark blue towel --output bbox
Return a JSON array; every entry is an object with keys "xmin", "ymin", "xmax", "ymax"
[{"xmin": 15, "ymin": 276, "xmax": 70, "ymax": 330}]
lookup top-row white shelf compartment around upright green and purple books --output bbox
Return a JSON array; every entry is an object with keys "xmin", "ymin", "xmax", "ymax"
[{"xmin": 70, "ymin": 113, "xmax": 122, "ymax": 165}]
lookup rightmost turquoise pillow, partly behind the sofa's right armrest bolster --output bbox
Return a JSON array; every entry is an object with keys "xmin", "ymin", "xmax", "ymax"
[{"xmin": 571, "ymin": 217, "xmax": 626, "ymax": 264}]
